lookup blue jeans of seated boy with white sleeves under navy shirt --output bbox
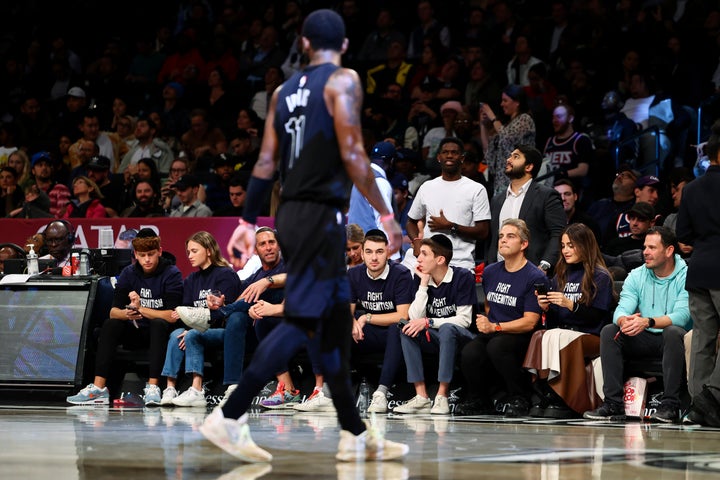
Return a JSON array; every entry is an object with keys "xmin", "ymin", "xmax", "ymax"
[{"xmin": 400, "ymin": 323, "xmax": 474, "ymax": 383}]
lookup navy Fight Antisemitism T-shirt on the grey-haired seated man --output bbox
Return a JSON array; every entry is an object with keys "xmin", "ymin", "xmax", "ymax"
[{"xmin": 483, "ymin": 262, "xmax": 549, "ymax": 323}]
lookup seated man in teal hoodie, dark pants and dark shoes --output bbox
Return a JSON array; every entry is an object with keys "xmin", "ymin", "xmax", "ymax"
[{"xmin": 583, "ymin": 227, "xmax": 692, "ymax": 423}]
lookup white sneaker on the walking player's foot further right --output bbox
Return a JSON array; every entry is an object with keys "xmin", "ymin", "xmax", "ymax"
[{"xmin": 335, "ymin": 422, "xmax": 410, "ymax": 462}]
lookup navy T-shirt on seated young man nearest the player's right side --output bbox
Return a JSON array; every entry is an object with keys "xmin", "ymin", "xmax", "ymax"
[{"xmin": 348, "ymin": 262, "xmax": 415, "ymax": 314}]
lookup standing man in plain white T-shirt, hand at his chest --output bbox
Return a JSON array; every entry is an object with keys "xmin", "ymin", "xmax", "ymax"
[{"xmin": 407, "ymin": 137, "xmax": 490, "ymax": 271}]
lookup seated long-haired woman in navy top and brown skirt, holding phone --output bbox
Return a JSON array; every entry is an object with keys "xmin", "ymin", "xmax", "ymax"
[{"xmin": 523, "ymin": 223, "xmax": 616, "ymax": 418}]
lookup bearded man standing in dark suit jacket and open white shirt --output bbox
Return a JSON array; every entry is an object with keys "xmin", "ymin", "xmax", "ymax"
[{"xmin": 486, "ymin": 145, "xmax": 567, "ymax": 273}]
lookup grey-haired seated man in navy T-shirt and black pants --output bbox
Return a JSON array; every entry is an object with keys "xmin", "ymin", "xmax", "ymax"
[{"xmin": 455, "ymin": 218, "xmax": 548, "ymax": 417}]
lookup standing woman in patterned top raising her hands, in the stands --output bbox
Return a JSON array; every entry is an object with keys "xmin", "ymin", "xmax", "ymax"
[{"xmin": 479, "ymin": 85, "xmax": 535, "ymax": 198}]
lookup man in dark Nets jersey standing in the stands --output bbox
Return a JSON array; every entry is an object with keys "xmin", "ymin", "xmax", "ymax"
[{"xmin": 544, "ymin": 104, "xmax": 594, "ymax": 188}]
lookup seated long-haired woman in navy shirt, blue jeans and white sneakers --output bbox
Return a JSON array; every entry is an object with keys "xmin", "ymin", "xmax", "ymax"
[{"xmin": 160, "ymin": 231, "xmax": 244, "ymax": 407}]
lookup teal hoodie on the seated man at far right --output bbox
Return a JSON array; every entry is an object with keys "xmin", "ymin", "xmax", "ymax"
[{"xmin": 613, "ymin": 254, "xmax": 692, "ymax": 332}]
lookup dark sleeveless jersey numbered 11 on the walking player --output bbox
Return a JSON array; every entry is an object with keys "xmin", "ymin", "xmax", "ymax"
[{"xmin": 273, "ymin": 63, "xmax": 351, "ymax": 207}]
